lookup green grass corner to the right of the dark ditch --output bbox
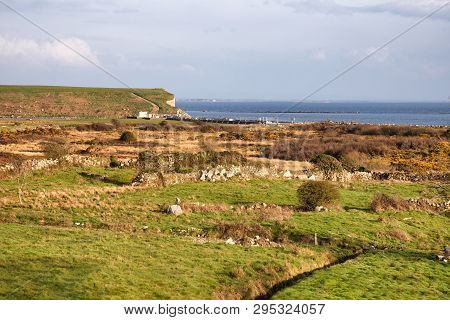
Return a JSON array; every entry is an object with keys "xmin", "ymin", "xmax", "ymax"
[{"xmin": 273, "ymin": 251, "xmax": 450, "ymax": 300}]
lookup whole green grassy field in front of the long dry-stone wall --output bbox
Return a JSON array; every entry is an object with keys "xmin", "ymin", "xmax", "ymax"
[{"xmin": 0, "ymin": 168, "xmax": 450, "ymax": 299}]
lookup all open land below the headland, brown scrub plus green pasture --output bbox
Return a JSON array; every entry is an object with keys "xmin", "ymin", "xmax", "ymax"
[{"xmin": 0, "ymin": 120, "xmax": 450, "ymax": 299}]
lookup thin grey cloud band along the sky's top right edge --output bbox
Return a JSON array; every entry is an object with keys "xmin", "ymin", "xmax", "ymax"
[{"xmin": 275, "ymin": 0, "xmax": 450, "ymax": 20}]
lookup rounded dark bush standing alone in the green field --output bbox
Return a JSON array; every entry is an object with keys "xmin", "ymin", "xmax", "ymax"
[{"xmin": 297, "ymin": 181, "xmax": 339, "ymax": 211}]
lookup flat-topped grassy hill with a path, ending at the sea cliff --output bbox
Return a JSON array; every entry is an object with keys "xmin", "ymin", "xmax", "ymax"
[{"xmin": 0, "ymin": 86, "xmax": 175, "ymax": 118}]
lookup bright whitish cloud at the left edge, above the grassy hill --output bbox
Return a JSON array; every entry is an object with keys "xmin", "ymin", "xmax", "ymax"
[{"xmin": 0, "ymin": 36, "xmax": 98, "ymax": 66}]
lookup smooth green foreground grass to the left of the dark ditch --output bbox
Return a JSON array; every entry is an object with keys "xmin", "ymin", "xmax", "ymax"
[{"xmin": 0, "ymin": 224, "xmax": 334, "ymax": 299}]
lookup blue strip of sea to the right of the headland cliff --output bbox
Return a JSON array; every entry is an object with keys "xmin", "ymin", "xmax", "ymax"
[{"xmin": 177, "ymin": 100, "xmax": 450, "ymax": 126}]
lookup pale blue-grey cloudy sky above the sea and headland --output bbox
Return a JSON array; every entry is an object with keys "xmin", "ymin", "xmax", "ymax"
[{"xmin": 0, "ymin": 0, "xmax": 450, "ymax": 101}]
